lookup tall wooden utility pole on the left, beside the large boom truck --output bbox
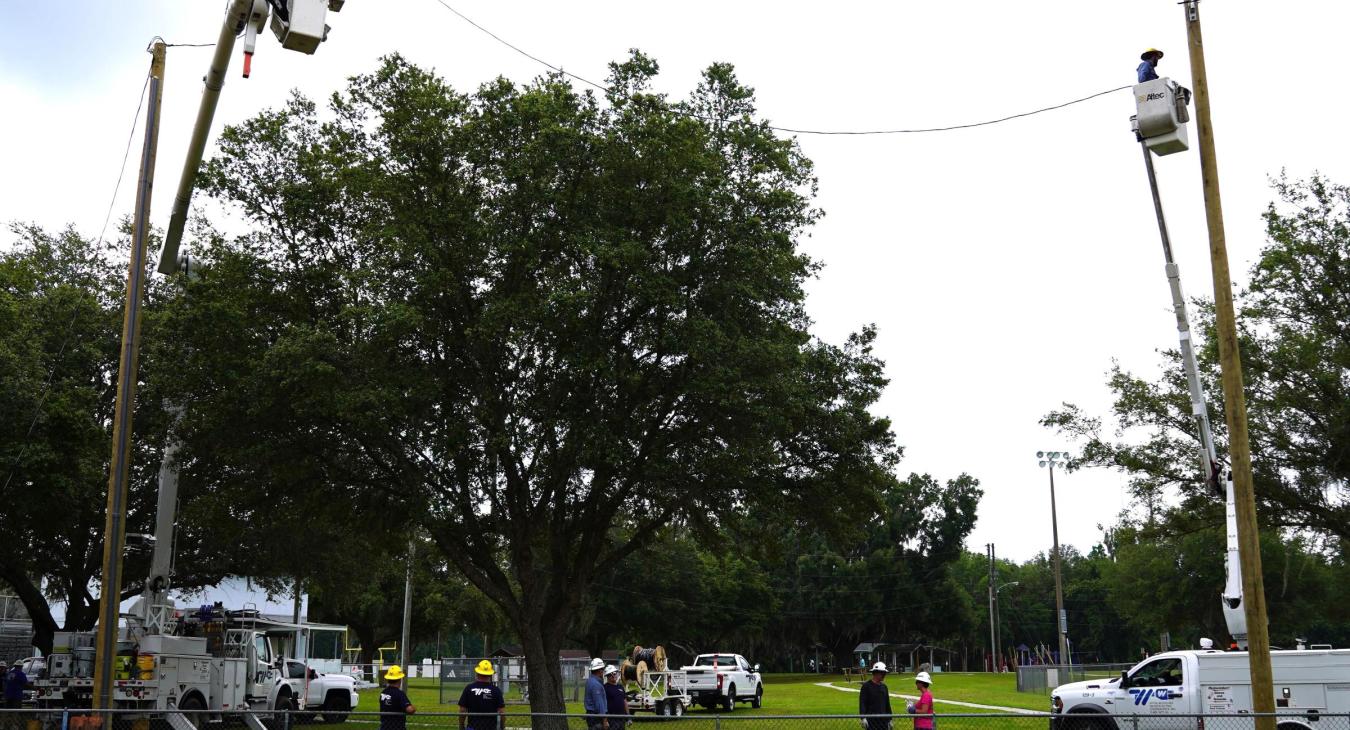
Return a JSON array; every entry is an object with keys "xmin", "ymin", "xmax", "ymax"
[{"xmin": 93, "ymin": 40, "xmax": 165, "ymax": 710}]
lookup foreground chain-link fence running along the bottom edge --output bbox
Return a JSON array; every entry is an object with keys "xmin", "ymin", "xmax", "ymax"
[{"xmin": 0, "ymin": 708, "xmax": 1350, "ymax": 730}]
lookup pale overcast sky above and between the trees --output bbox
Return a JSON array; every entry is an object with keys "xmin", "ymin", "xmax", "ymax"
[{"xmin": 0, "ymin": 0, "xmax": 1350, "ymax": 564}]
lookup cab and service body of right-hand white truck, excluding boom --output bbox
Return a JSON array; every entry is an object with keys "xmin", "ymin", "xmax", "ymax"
[{"xmin": 1050, "ymin": 649, "xmax": 1350, "ymax": 730}]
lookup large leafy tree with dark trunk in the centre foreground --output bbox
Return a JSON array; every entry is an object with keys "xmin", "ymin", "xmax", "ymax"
[{"xmin": 174, "ymin": 54, "xmax": 898, "ymax": 710}]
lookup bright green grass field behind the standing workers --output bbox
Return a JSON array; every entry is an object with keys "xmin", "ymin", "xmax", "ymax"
[{"xmin": 391, "ymin": 672, "xmax": 1049, "ymax": 717}]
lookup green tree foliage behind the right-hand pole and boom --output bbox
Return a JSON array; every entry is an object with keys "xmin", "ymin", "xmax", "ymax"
[{"xmin": 1045, "ymin": 177, "xmax": 1350, "ymax": 542}]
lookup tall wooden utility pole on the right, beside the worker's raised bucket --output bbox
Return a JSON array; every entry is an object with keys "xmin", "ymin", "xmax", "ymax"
[{"xmin": 1183, "ymin": 0, "xmax": 1274, "ymax": 730}]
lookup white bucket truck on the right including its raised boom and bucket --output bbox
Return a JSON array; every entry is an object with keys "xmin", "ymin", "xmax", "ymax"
[{"xmin": 1050, "ymin": 89, "xmax": 1350, "ymax": 730}]
